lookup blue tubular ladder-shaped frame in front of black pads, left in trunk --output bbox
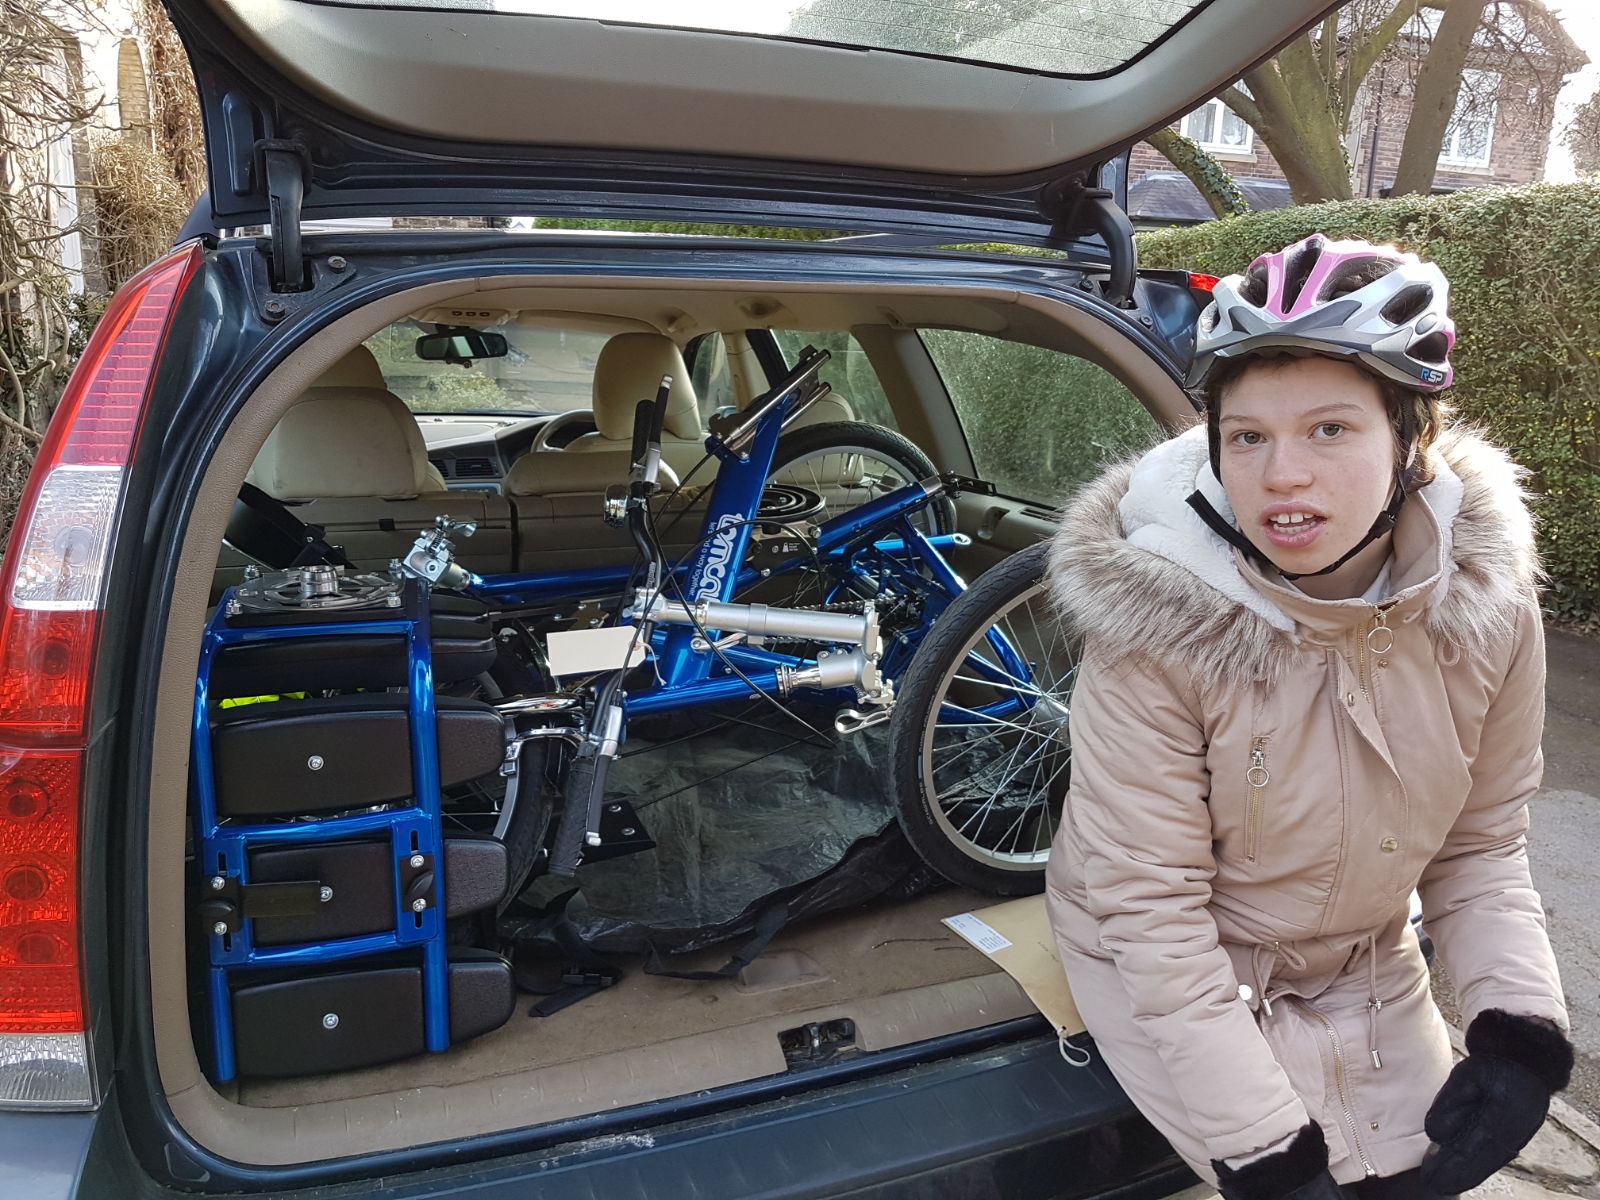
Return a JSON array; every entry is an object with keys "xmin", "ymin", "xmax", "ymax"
[{"xmin": 190, "ymin": 581, "xmax": 450, "ymax": 1083}]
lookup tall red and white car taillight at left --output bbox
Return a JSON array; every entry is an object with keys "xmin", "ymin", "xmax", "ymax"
[{"xmin": 0, "ymin": 245, "xmax": 202, "ymax": 1109}]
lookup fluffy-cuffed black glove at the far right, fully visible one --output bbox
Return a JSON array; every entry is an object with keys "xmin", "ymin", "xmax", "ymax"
[{"xmin": 1422, "ymin": 1008, "xmax": 1573, "ymax": 1195}]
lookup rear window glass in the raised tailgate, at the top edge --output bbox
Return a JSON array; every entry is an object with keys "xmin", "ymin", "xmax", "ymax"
[{"xmin": 340, "ymin": 0, "xmax": 1210, "ymax": 75}]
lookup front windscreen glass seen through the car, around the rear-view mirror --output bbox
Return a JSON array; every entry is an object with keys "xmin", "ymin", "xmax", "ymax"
[{"xmin": 366, "ymin": 320, "xmax": 608, "ymax": 414}]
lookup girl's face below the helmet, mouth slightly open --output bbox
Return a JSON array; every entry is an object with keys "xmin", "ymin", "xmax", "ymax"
[{"xmin": 1219, "ymin": 358, "xmax": 1397, "ymax": 598}]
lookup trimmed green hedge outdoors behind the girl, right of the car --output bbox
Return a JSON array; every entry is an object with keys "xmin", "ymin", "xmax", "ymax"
[{"xmin": 1139, "ymin": 181, "xmax": 1600, "ymax": 630}]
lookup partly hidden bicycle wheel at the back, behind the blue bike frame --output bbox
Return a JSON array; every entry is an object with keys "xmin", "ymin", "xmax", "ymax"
[{"xmin": 768, "ymin": 421, "xmax": 955, "ymax": 534}]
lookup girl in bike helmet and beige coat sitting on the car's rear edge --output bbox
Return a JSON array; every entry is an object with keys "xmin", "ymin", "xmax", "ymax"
[{"xmin": 1048, "ymin": 237, "xmax": 1571, "ymax": 1200}]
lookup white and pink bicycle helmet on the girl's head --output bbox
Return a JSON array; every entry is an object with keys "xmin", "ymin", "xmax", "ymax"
[{"xmin": 1189, "ymin": 234, "xmax": 1456, "ymax": 392}]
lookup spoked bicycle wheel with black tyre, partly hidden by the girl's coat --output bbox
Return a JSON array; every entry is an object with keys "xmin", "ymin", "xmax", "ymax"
[{"xmin": 890, "ymin": 544, "xmax": 1078, "ymax": 896}]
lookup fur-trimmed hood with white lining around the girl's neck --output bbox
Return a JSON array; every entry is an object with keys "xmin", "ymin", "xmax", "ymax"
[{"xmin": 1046, "ymin": 427, "xmax": 1541, "ymax": 686}]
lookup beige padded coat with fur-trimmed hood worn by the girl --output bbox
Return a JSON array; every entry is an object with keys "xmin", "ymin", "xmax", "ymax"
[{"xmin": 1048, "ymin": 429, "xmax": 1566, "ymax": 1182}]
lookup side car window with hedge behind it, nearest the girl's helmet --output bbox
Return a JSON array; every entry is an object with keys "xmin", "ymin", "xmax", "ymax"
[{"xmin": 922, "ymin": 330, "xmax": 1157, "ymax": 504}]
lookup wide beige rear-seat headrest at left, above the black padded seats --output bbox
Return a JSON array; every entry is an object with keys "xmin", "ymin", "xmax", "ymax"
[{"xmin": 246, "ymin": 387, "xmax": 435, "ymax": 501}]
